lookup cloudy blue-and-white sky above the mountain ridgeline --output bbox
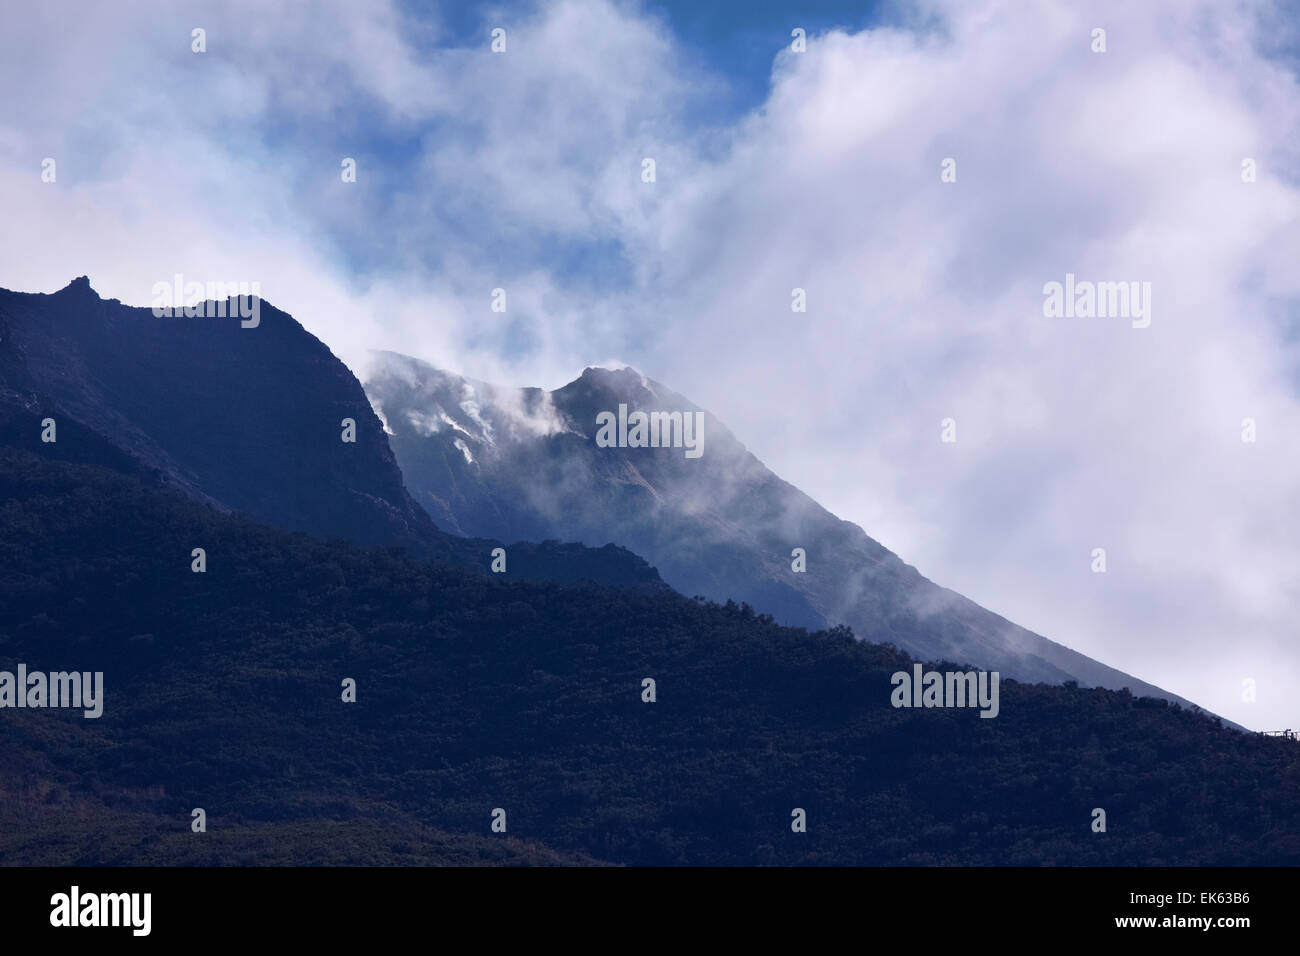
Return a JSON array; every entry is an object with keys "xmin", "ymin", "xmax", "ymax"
[{"xmin": 0, "ymin": 0, "xmax": 1300, "ymax": 730}]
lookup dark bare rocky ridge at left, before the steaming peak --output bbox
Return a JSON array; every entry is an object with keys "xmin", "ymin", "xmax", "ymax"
[{"xmin": 0, "ymin": 276, "xmax": 664, "ymax": 589}]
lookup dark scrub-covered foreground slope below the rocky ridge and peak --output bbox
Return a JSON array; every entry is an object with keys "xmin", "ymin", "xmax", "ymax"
[{"xmin": 0, "ymin": 449, "xmax": 1300, "ymax": 865}]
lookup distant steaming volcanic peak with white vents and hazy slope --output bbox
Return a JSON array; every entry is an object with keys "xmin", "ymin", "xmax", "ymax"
[{"xmin": 365, "ymin": 352, "xmax": 1206, "ymax": 706}]
